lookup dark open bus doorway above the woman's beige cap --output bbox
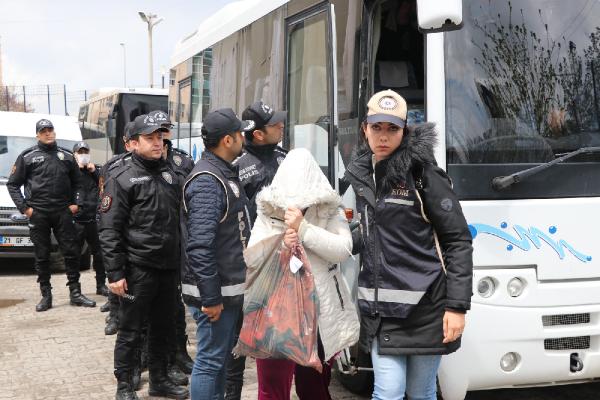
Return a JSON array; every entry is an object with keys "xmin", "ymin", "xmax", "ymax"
[{"xmin": 371, "ymin": 0, "xmax": 425, "ymax": 125}]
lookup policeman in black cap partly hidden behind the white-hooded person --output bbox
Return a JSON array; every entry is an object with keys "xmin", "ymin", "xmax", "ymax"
[{"xmin": 225, "ymin": 101, "xmax": 287, "ymax": 400}]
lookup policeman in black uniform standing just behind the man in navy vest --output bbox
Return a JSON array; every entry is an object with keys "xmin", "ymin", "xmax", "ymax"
[{"xmin": 100, "ymin": 115, "xmax": 189, "ymax": 400}]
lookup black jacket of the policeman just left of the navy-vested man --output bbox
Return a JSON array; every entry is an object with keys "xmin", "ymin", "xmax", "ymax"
[{"xmin": 99, "ymin": 154, "xmax": 181, "ymax": 282}]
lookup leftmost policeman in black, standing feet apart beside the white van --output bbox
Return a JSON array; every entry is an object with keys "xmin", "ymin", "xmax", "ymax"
[{"xmin": 6, "ymin": 119, "xmax": 96, "ymax": 311}]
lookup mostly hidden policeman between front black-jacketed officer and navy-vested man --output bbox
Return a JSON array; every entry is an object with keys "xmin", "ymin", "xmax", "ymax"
[{"xmin": 149, "ymin": 111, "xmax": 194, "ymax": 378}]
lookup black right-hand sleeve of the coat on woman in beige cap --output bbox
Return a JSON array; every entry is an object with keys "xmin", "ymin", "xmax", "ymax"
[{"xmin": 423, "ymin": 165, "xmax": 473, "ymax": 311}]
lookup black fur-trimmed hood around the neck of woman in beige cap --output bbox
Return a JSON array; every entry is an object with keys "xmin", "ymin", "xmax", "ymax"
[{"xmin": 348, "ymin": 122, "xmax": 437, "ymax": 189}]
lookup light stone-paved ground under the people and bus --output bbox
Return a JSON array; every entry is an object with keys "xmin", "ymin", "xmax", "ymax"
[{"xmin": 0, "ymin": 259, "xmax": 600, "ymax": 400}]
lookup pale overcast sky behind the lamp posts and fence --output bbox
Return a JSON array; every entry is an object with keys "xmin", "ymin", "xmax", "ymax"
[{"xmin": 0, "ymin": 0, "xmax": 232, "ymax": 115}]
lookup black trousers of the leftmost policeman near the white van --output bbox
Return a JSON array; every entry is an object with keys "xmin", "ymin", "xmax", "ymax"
[{"xmin": 29, "ymin": 207, "xmax": 80, "ymax": 287}]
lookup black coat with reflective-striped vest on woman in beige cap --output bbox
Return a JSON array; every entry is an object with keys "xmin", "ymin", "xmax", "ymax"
[{"xmin": 345, "ymin": 124, "xmax": 473, "ymax": 354}]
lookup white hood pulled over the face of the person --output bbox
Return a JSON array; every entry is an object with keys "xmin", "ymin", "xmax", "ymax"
[{"xmin": 256, "ymin": 148, "xmax": 342, "ymax": 216}]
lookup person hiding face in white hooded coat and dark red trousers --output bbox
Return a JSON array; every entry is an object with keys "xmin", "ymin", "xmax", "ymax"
[{"xmin": 244, "ymin": 148, "xmax": 359, "ymax": 400}]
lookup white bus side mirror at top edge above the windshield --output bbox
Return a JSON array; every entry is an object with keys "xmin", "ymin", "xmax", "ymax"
[{"xmin": 417, "ymin": 0, "xmax": 463, "ymax": 33}]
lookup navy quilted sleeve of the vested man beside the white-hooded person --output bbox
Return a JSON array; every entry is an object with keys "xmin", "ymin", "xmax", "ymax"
[{"xmin": 185, "ymin": 174, "xmax": 226, "ymax": 307}]
